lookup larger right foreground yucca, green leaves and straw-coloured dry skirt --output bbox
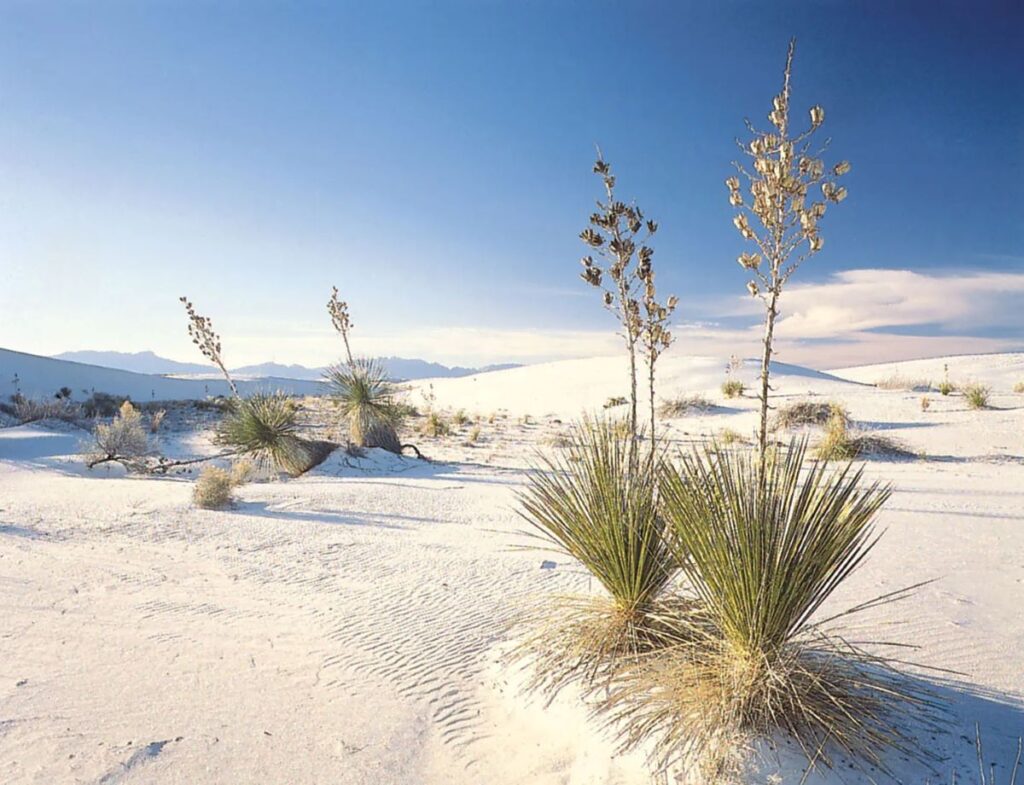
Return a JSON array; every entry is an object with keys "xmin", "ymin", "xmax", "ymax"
[{"xmin": 605, "ymin": 442, "xmax": 934, "ymax": 782}]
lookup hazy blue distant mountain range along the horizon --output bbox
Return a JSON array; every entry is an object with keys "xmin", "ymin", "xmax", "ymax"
[{"xmin": 53, "ymin": 351, "xmax": 518, "ymax": 380}]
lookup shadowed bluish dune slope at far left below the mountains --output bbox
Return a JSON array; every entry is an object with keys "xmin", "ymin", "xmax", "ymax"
[{"xmin": 0, "ymin": 349, "xmax": 323, "ymax": 401}]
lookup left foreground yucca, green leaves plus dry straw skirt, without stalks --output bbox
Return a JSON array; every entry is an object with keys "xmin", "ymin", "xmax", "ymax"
[{"xmin": 520, "ymin": 421, "xmax": 676, "ymax": 690}]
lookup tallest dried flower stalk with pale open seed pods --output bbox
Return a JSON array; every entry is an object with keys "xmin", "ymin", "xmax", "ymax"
[{"xmin": 725, "ymin": 39, "xmax": 850, "ymax": 457}]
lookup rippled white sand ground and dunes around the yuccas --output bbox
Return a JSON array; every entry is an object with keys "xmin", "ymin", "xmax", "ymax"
[{"xmin": 0, "ymin": 354, "xmax": 1024, "ymax": 785}]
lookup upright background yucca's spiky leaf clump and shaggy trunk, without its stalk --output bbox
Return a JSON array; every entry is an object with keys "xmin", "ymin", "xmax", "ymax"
[{"xmin": 325, "ymin": 360, "xmax": 402, "ymax": 453}]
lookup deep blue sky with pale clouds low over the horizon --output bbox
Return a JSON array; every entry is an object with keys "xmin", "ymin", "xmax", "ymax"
[{"xmin": 0, "ymin": 0, "xmax": 1024, "ymax": 364}]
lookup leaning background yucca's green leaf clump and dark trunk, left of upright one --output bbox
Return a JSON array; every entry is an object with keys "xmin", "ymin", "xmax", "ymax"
[{"xmin": 216, "ymin": 392, "xmax": 331, "ymax": 476}]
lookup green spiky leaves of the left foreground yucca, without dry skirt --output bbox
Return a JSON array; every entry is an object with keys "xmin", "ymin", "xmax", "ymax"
[{"xmin": 520, "ymin": 422, "xmax": 675, "ymax": 612}]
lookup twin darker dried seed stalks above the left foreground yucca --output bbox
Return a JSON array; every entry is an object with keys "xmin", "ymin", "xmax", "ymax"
[{"xmin": 580, "ymin": 150, "xmax": 676, "ymax": 448}]
